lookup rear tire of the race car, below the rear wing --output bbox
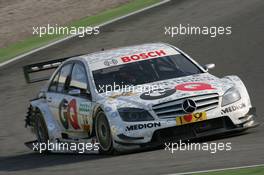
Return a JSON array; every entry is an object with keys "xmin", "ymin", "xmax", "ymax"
[{"xmin": 34, "ymin": 111, "xmax": 49, "ymax": 153}]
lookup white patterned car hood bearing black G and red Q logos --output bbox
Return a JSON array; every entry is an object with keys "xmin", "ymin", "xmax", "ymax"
[{"xmin": 101, "ymin": 73, "xmax": 234, "ymax": 108}]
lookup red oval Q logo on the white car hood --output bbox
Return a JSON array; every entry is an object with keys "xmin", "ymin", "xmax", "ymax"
[{"xmin": 175, "ymin": 82, "xmax": 215, "ymax": 91}]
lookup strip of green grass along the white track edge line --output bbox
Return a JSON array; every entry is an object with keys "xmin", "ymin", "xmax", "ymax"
[{"xmin": 0, "ymin": 0, "xmax": 161, "ymax": 63}]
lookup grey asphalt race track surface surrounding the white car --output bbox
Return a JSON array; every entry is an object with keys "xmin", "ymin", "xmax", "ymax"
[{"xmin": 0, "ymin": 0, "xmax": 264, "ymax": 175}]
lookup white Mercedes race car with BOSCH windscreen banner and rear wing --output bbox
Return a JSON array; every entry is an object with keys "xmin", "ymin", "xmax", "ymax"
[{"xmin": 24, "ymin": 43, "xmax": 257, "ymax": 153}]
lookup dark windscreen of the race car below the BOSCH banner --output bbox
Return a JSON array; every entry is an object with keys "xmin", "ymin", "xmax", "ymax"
[{"xmin": 93, "ymin": 54, "xmax": 202, "ymax": 93}]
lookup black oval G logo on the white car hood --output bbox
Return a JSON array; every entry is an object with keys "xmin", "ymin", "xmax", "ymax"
[{"xmin": 140, "ymin": 88, "xmax": 176, "ymax": 100}]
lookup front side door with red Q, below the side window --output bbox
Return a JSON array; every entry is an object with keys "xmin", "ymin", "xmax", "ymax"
[{"xmin": 63, "ymin": 62, "xmax": 92, "ymax": 137}]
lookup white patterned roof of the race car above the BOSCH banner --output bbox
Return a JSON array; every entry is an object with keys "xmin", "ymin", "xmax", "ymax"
[{"xmin": 81, "ymin": 43, "xmax": 175, "ymax": 63}]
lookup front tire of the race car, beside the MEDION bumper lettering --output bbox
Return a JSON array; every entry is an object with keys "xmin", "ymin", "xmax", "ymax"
[{"xmin": 95, "ymin": 111, "xmax": 117, "ymax": 155}]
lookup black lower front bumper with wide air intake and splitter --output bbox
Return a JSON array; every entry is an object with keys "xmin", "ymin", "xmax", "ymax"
[{"xmin": 116, "ymin": 108, "xmax": 259, "ymax": 147}]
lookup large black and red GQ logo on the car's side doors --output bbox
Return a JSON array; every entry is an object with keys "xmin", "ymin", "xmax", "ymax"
[{"xmin": 59, "ymin": 99, "xmax": 80, "ymax": 129}]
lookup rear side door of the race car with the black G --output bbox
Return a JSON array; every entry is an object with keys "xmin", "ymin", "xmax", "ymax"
[{"xmin": 46, "ymin": 63, "xmax": 73, "ymax": 131}]
